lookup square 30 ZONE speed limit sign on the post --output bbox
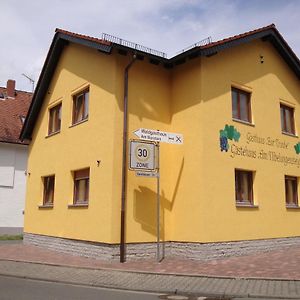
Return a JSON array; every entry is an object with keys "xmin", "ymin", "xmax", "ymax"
[{"xmin": 129, "ymin": 141, "xmax": 156, "ymax": 171}]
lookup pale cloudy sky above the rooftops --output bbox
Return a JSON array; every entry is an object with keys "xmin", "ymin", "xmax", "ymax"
[{"xmin": 0, "ymin": 0, "xmax": 300, "ymax": 90}]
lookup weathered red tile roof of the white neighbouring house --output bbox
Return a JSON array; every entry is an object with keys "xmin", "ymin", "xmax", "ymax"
[{"xmin": 0, "ymin": 87, "xmax": 32, "ymax": 144}]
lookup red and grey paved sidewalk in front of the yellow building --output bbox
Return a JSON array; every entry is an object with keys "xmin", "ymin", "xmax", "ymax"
[{"xmin": 0, "ymin": 243, "xmax": 300, "ymax": 299}]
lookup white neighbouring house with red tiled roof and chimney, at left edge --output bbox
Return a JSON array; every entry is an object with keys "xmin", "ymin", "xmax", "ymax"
[{"xmin": 0, "ymin": 80, "xmax": 32, "ymax": 234}]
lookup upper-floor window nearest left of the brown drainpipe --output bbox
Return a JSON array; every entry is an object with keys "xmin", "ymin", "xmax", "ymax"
[{"xmin": 72, "ymin": 90, "xmax": 89, "ymax": 124}]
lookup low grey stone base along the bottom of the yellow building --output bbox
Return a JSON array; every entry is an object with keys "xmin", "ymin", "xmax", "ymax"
[{"xmin": 24, "ymin": 233, "xmax": 300, "ymax": 261}]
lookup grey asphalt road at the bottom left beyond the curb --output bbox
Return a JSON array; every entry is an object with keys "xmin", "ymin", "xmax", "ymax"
[{"xmin": 0, "ymin": 275, "xmax": 159, "ymax": 300}]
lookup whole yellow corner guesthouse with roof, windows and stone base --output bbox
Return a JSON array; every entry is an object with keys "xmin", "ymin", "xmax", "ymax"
[{"xmin": 21, "ymin": 24, "xmax": 300, "ymax": 261}]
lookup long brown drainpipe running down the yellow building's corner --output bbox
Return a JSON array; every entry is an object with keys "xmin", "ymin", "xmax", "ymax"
[{"xmin": 120, "ymin": 54, "xmax": 136, "ymax": 263}]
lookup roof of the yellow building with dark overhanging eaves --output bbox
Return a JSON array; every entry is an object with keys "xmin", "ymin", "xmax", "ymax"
[{"xmin": 21, "ymin": 24, "xmax": 300, "ymax": 139}]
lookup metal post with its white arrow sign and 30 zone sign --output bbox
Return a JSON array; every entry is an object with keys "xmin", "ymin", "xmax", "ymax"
[{"xmin": 129, "ymin": 128, "xmax": 183, "ymax": 262}]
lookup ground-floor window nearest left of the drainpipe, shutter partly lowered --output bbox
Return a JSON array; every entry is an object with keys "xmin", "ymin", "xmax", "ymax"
[{"xmin": 74, "ymin": 168, "xmax": 90, "ymax": 204}]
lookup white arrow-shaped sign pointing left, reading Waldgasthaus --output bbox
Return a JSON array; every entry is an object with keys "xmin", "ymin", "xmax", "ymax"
[{"xmin": 133, "ymin": 128, "xmax": 183, "ymax": 145}]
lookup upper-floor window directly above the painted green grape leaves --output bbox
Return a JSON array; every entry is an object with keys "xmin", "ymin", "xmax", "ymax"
[{"xmin": 231, "ymin": 88, "xmax": 251, "ymax": 123}]
